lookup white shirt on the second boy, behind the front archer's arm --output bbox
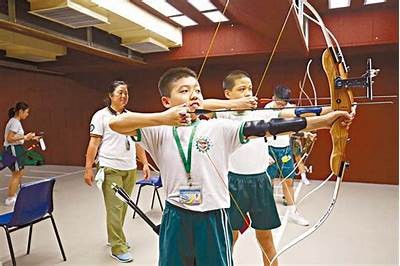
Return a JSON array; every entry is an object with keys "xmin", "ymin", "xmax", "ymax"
[{"xmin": 216, "ymin": 110, "xmax": 276, "ymax": 175}]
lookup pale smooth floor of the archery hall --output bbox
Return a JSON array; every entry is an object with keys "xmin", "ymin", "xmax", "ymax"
[{"xmin": 0, "ymin": 165, "xmax": 399, "ymax": 266}]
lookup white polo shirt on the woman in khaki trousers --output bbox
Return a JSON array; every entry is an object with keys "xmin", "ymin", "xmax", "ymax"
[{"xmin": 90, "ymin": 107, "xmax": 137, "ymax": 170}]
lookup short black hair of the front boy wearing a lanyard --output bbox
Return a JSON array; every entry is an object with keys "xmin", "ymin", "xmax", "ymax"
[{"xmin": 158, "ymin": 67, "xmax": 197, "ymax": 97}]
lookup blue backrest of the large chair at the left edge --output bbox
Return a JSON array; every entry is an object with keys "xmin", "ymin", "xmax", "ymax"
[{"xmin": 8, "ymin": 178, "xmax": 56, "ymax": 226}]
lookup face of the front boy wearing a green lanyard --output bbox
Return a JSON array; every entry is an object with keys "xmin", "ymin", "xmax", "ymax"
[{"xmin": 161, "ymin": 76, "xmax": 203, "ymax": 112}]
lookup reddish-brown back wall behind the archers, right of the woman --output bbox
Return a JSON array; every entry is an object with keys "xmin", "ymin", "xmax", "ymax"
[{"xmin": 75, "ymin": 52, "xmax": 398, "ymax": 184}]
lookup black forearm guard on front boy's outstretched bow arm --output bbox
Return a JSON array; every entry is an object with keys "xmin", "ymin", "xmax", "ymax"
[{"xmin": 243, "ymin": 117, "xmax": 307, "ymax": 137}]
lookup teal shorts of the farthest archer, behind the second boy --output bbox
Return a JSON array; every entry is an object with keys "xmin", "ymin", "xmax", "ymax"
[{"xmin": 267, "ymin": 146, "xmax": 296, "ymax": 178}]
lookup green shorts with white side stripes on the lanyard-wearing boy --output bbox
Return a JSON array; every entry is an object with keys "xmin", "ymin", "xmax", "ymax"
[{"xmin": 158, "ymin": 202, "xmax": 233, "ymax": 266}]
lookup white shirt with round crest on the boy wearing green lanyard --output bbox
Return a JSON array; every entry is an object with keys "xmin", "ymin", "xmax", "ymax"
[{"xmin": 137, "ymin": 119, "xmax": 247, "ymax": 212}]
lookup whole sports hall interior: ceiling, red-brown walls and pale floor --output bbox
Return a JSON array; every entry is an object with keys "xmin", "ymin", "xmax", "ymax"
[{"xmin": 0, "ymin": 0, "xmax": 399, "ymax": 265}]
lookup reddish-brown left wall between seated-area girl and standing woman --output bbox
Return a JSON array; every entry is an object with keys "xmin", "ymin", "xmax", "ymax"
[{"xmin": 0, "ymin": 68, "xmax": 102, "ymax": 165}]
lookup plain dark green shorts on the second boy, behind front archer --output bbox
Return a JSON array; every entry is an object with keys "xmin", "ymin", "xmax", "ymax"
[{"xmin": 228, "ymin": 172, "xmax": 281, "ymax": 230}]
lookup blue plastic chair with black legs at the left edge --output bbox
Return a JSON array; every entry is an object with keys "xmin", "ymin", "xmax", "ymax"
[{"xmin": 0, "ymin": 178, "xmax": 67, "ymax": 266}]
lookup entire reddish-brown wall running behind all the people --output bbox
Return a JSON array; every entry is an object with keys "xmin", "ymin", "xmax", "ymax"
[{"xmin": 0, "ymin": 49, "xmax": 398, "ymax": 184}]
